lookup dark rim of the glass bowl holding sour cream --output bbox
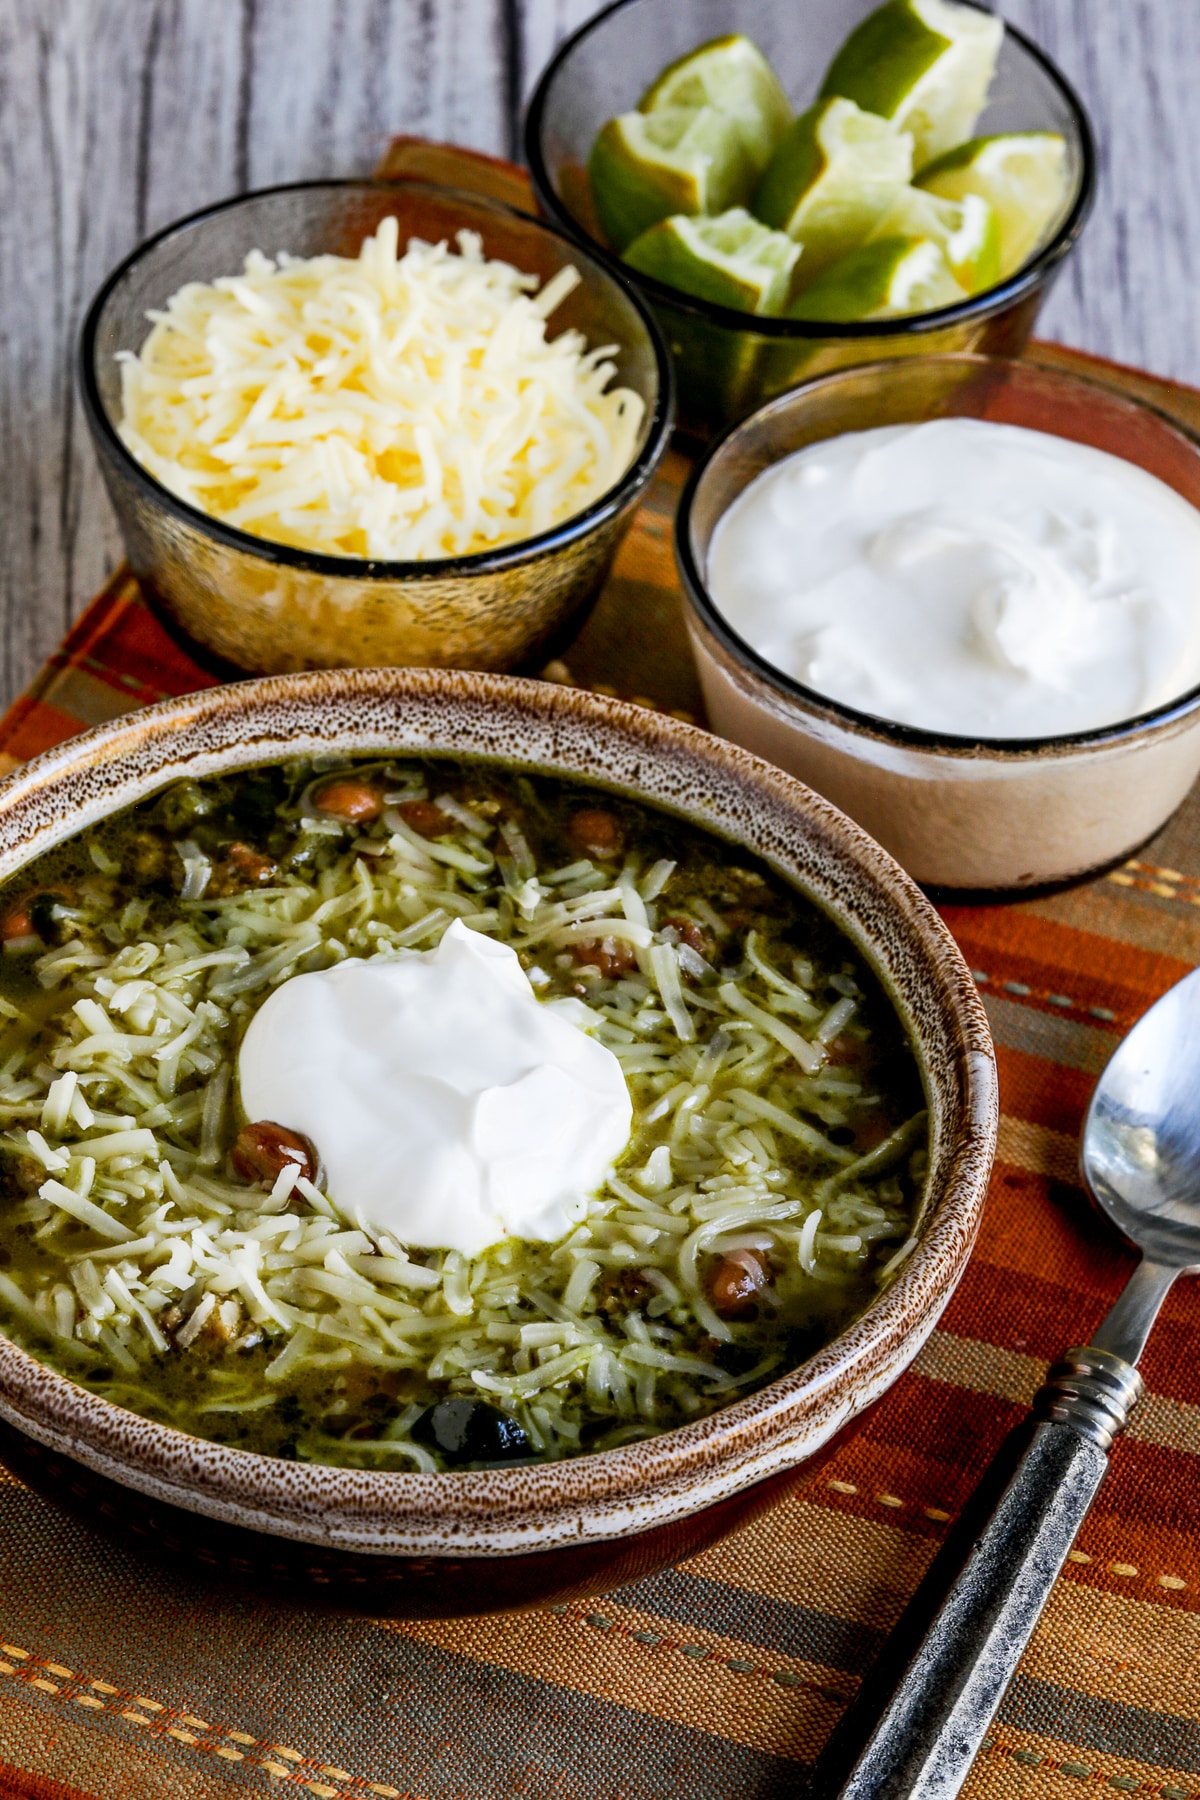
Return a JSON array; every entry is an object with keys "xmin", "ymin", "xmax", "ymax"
[{"xmin": 676, "ymin": 354, "xmax": 1200, "ymax": 761}]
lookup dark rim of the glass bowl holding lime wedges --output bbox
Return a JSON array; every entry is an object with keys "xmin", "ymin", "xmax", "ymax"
[{"xmin": 524, "ymin": 0, "xmax": 1096, "ymax": 344}]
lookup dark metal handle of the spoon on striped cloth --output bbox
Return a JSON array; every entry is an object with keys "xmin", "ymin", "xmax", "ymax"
[{"xmin": 813, "ymin": 1346, "xmax": 1142, "ymax": 1800}]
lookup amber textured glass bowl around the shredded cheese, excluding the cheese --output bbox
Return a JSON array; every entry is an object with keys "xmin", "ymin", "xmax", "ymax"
[{"xmin": 79, "ymin": 182, "xmax": 671, "ymax": 673}]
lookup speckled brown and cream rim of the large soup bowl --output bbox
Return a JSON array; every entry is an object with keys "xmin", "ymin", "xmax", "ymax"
[{"xmin": 0, "ymin": 670, "xmax": 999, "ymax": 1557}]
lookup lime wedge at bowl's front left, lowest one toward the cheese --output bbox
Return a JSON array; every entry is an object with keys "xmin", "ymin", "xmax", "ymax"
[{"xmin": 624, "ymin": 207, "xmax": 801, "ymax": 315}]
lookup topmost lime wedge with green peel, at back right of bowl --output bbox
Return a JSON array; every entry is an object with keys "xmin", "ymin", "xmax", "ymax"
[{"xmin": 820, "ymin": 0, "xmax": 1004, "ymax": 169}]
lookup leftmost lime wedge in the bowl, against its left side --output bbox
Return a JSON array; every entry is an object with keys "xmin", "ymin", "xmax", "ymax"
[{"xmin": 588, "ymin": 106, "xmax": 754, "ymax": 250}]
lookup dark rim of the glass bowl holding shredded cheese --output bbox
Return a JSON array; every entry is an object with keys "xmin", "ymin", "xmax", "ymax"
[{"xmin": 77, "ymin": 176, "xmax": 675, "ymax": 581}]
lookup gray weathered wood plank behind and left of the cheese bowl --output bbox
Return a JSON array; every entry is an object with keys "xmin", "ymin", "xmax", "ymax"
[{"xmin": 0, "ymin": 0, "xmax": 515, "ymax": 702}]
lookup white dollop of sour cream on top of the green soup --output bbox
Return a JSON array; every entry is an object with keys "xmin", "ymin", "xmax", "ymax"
[{"xmin": 237, "ymin": 920, "xmax": 633, "ymax": 1256}]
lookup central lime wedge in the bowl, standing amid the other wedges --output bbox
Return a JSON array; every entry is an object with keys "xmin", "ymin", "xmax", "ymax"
[{"xmin": 754, "ymin": 99, "xmax": 912, "ymax": 275}]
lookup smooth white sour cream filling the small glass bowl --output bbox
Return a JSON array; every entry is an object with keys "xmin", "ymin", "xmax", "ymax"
[{"xmin": 707, "ymin": 419, "xmax": 1200, "ymax": 738}]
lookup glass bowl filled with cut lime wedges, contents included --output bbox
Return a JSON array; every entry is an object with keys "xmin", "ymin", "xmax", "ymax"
[{"xmin": 525, "ymin": 0, "xmax": 1096, "ymax": 436}]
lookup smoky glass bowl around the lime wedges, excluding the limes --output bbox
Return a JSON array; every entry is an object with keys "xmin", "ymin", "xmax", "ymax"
[{"xmin": 525, "ymin": 0, "xmax": 1096, "ymax": 434}]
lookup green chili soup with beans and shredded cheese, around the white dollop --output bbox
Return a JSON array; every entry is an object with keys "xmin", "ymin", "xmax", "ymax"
[{"xmin": 0, "ymin": 756, "xmax": 928, "ymax": 1471}]
